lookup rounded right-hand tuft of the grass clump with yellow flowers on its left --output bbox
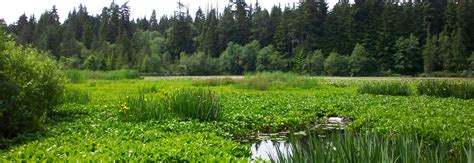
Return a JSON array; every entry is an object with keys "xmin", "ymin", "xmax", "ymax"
[{"xmin": 168, "ymin": 89, "xmax": 221, "ymax": 121}]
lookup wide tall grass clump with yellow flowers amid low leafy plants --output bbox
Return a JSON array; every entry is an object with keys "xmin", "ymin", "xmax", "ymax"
[{"xmin": 119, "ymin": 89, "xmax": 221, "ymax": 121}]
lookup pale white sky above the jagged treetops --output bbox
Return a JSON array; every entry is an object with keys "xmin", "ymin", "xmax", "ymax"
[{"xmin": 0, "ymin": 0, "xmax": 338, "ymax": 24}]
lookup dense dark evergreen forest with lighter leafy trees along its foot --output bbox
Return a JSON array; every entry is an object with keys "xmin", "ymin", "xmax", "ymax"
[{"xmin": 6, "ymin": 0, "xmax": 474, "ymax": 76}]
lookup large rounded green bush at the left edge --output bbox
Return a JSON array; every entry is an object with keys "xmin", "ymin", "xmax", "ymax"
[{"xmin": 0, "ymin": 33, "xmax": 64, "ymax": 137}]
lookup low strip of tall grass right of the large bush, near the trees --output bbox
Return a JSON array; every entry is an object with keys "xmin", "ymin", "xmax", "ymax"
[{"xmin": 65, "ymin": 70, "xmax": 140, "ymax": 83}]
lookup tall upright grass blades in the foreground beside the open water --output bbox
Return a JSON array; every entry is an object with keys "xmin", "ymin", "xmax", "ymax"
[{"xmin": 271, "ymin": 134, "xmax": 474, "ymax": 162}]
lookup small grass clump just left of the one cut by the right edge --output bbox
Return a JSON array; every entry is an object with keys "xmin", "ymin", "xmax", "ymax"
[{"xmin": 357, "ymin": 81, "xmax": 411, "ymax": 96}]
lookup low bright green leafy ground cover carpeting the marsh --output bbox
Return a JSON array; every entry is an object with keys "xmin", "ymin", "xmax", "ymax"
[{"xmin": 0, "ymin": 76, "xmax": 474, "ymax": 160}]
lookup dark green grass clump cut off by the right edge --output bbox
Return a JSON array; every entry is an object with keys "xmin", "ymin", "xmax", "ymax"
[{"xmin": 416, "ymin": 80, "xmax": 474, "ymax": 99}]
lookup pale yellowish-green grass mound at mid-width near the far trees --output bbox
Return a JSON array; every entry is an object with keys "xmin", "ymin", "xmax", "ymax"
[{"xmin": 238, "ymin": 72, "xmax": 320, "ymax": 91}]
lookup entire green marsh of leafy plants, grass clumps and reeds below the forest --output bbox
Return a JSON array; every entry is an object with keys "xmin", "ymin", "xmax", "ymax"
[{"xmin": 0, "ymin": 73, "xmax": 474, "ymax": 162}]
